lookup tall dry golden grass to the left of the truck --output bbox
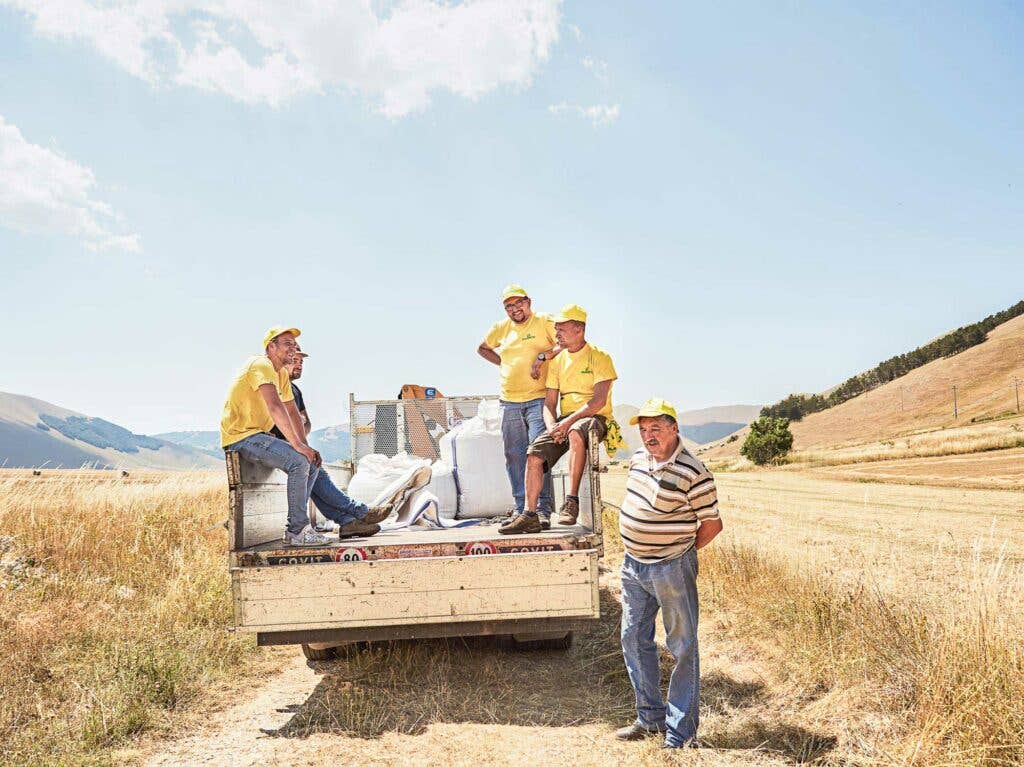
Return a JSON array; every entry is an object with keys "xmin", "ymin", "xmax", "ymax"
[{"xmin": 0, "ymin": 472, "xmax": 252, "ymax": 765}]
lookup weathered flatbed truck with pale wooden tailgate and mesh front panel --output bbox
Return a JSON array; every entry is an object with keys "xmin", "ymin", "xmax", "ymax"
[{"xmin": 227, "ymin": 397, "xmax": 602, "ymax": 658}]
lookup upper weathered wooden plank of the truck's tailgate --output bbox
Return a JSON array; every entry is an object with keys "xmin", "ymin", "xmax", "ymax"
[{"xmin": 239, "ymin": 550, "xmax": 596, "ymax": 600}]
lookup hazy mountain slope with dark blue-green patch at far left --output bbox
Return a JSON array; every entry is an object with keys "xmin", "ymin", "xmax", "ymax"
[{"xmin": 0, "ymin": 392, "xmax": 218, "ymax": 469}]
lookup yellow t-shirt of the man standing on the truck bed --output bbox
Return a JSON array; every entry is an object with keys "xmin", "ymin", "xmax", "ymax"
[{"xmin": 483, "ymin": 311, "xmax": 555, "ymax": 402}]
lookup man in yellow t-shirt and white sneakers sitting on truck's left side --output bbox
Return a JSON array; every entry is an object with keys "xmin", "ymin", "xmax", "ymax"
[{"xmin": 220, "ymin": 327, "xmax": 328, "ymax": 546}]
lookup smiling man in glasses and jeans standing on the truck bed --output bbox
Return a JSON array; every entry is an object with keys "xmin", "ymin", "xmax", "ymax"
[{"xmin": 476, "ymin": 285, "xmax": 561, "ymax": 527}]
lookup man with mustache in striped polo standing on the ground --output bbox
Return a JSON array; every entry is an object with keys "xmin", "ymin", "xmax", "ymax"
[{"xmin": 615, "ymin": 398, "xmax": 722, "ymax": 749}]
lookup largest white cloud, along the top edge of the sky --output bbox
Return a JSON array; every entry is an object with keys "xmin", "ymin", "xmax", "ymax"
[{"xmin": 0, "ymin": 0, "xmax": 561, "ymax": 118}]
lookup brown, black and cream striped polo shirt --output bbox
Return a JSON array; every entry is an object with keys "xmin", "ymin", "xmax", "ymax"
[{"xmin": 618, "ymin": 439, "xmax": 718, "ymax": 563}]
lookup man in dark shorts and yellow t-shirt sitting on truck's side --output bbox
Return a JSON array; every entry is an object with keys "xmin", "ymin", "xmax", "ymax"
[{"xmin": 498, "ymin": 304, "xmax": 617, "ymax": 535}]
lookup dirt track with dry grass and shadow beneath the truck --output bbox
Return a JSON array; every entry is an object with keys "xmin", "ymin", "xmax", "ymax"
[{"xmin": 136, "ymin": 572, "xmax": 835, "ymax": 767}]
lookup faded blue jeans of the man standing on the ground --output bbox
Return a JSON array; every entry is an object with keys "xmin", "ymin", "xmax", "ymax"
[{"xmin": 622, "ymin": 548, "xmax": 700, "ymax": 747}]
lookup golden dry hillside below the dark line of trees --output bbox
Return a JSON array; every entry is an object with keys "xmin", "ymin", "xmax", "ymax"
[{"xmin": 706, "ymin": 307, "xmax": 1024, "ymax": 458}]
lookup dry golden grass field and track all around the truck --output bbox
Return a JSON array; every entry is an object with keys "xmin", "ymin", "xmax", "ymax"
[{"xmin": 0, "ymin": 462, "xmax": 1024, "ymax": 767}]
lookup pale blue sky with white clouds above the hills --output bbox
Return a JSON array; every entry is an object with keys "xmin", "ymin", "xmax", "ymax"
[{"xmin": 0, "ymin": 0, "xmax": 1024, "ymax": 433}]
